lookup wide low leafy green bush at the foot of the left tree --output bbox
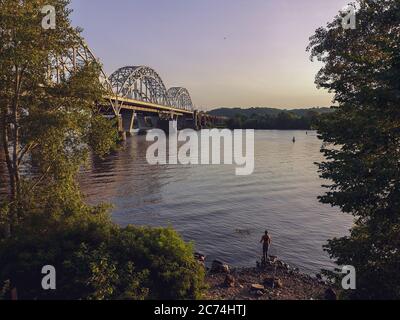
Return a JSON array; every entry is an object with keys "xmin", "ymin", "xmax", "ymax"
[{"xmin": 0, "ymin": 215, "xmax": 204, "ymax": 300}]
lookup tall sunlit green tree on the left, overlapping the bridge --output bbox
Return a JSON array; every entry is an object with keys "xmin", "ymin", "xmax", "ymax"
[{"xmin": 0, "ymin": 0, "xmax": 116, "ymax": 237}]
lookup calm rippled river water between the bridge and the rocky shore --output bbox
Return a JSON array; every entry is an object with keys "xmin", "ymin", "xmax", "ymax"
[{"xmin": 81, "ymin": 131, "xmax": 351, "ymax": 272}]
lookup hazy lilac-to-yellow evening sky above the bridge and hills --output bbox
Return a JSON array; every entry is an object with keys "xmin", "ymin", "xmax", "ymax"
[{"xmin": 71, "ymin": 0, "xmax": 348, "ymax": 109}]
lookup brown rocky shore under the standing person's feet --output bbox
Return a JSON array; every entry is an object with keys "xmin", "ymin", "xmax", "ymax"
[{"xmin": 196, "ymin": 254, "xmax": 336, "ymax": 300}]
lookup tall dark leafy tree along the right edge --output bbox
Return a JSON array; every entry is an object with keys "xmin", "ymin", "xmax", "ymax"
[{"xmin": 308, "ymin": 0, "xmax": 400, "ymax": 299}]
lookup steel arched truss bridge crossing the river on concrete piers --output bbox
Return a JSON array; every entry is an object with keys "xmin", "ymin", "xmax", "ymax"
[{"xmin": 49, "ymin": 37, "xmax": 225, "ymax": 132}]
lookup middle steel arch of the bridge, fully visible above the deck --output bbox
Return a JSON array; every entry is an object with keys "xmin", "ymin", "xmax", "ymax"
[{"xmin": 109, "ymin": 66, "xmax": 171, "ymax": 106}]
